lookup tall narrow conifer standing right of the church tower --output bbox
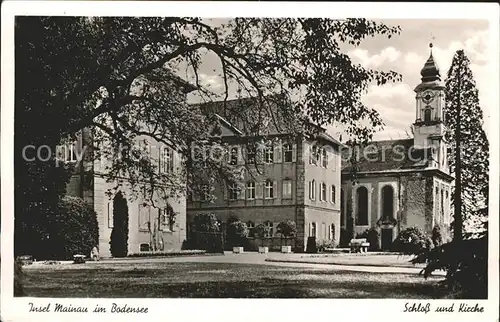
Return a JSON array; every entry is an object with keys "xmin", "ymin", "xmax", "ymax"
[{"xmin": 445, "ymin": 50, "xmax": 489, "ymax": 240}]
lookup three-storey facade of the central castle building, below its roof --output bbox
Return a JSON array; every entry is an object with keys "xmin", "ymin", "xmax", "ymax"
[{"xmin": 187, "ymin": 107, "xmax": 341, "ymax": 251}]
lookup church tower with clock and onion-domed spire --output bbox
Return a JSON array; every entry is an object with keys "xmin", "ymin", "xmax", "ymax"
[{"xmin": 413, "ymin": 43, "xmax": 449, "ymax": 173}]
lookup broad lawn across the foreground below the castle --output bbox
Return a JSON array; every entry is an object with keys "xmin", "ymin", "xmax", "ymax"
[{"xmin": 19, "ymin": 262, "xmax": 446, "ymax": 299}]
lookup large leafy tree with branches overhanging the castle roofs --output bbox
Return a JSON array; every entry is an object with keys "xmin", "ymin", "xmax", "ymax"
[{"xmin": 15, "ymin": 17, "xmax": 400, "ymax": 252}]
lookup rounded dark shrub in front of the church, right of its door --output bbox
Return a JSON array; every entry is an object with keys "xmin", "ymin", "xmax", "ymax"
[{"xmin": 392, "ymin": 227, "xmax": 433, "ymax": 255}]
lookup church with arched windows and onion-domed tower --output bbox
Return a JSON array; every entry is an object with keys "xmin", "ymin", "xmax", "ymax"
[{"xmin": 341, "ymin": 44, "xmax": 453, "ymax": 249}]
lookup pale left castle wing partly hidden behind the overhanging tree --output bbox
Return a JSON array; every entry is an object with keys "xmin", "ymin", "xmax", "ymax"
[{"xmin": 62, "ymin": 77, "xmax": 194, "ymax": 257}]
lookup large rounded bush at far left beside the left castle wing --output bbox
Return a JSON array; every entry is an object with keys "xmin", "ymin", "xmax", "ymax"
[{"xmin": 36, "ymin": 196, "xmax": 99, "ymax": 259}]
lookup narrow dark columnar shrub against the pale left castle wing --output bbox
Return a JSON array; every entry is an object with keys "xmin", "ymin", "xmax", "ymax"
[{"xmin": 109, "ymin": 192, "xmax": 128, "ymax": 257}]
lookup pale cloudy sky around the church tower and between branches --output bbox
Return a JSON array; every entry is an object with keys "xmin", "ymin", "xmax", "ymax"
[{"xmin": 181, "ymin": 19, "xmax": 497, "ymax": 140}]
